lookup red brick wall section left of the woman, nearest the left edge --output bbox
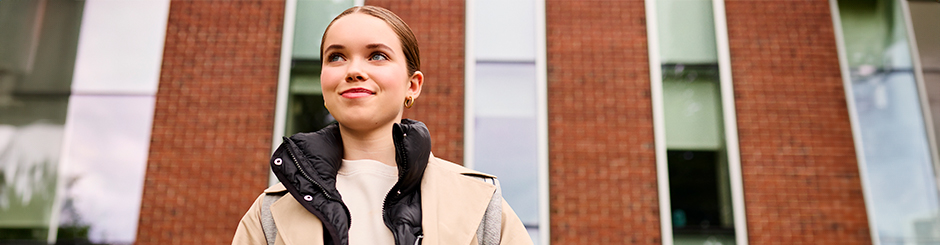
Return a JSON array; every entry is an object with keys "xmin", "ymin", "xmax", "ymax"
[{"xmin": 137, "ymin": 0, "xmax": 284, "ymax": 244}]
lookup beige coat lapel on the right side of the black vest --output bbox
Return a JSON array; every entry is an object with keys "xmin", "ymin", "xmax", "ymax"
[{"xmin": 421, "ymin": 156, "xmax": 496, "ymax": 245}]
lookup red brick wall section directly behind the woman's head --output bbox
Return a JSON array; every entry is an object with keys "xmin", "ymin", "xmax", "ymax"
[{"xmin": 365, "ymin": 0, "xmax": 466, "ymax": 163}]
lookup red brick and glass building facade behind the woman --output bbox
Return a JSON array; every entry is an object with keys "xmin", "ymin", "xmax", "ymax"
[{"xmin": 0, "ymin": 0, "xmax": 940, "ymax": 244}]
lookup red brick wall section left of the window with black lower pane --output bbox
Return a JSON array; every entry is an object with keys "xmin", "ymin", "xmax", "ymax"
[{"xmin": 546, "ymin": 0, "xmax": 660, "ymax": 244}]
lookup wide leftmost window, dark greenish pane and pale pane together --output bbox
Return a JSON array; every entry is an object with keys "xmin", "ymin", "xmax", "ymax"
[{"xmin": 0, "ymin": 0, "xmax": 169, "ymax": 244}]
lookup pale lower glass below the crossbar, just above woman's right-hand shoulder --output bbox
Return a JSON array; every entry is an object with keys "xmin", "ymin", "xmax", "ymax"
[{"xmin": 472, "ymin": 62, "xmax": 539, "ymax": 243}]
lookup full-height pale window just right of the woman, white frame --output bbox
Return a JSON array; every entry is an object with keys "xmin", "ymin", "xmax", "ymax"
[{"xmin": 465, "ymin": 0, "xmax": 545, "ymax": 244}]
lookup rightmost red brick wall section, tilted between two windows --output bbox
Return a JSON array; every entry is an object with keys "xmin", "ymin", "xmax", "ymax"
[{"xmin": 726, "ymin": 0, "xmax": 871, "ymax": 244}]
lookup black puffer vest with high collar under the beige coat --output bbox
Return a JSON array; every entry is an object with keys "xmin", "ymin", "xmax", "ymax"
[{"xmin": 271, "ymin": 119, "xmax": 431, "ymax": 245}]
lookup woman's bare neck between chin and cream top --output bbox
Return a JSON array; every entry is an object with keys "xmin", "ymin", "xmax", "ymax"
[{"xmin": 339, "ymin": 120, "xmax": 397, "ymax": 166}]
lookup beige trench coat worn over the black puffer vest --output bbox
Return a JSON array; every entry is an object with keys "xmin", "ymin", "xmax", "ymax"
[{"xmin": 232, "ymin": 156, "xmax": 532, "ymax": 245}]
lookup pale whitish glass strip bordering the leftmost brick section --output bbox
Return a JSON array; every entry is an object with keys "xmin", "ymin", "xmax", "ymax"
[{"xmin": 58, "ymin": 0, "xmax": 170, "ymax": 244}]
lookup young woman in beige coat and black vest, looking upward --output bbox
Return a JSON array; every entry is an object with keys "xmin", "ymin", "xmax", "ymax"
[{"xmin": 233, "ymin": 6, "xmax": 532, "ymax": 245}]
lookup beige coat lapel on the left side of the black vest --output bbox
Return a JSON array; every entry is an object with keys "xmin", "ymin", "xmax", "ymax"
[{"xmin": 271, "ymin": 190, "xmax": 323, "ymax": 245}]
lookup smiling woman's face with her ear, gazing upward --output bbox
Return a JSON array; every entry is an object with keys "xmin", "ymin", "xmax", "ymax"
[{"xmin": 320, "ymin": 13, "xmax": 424, "ymax": 130}]
